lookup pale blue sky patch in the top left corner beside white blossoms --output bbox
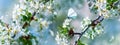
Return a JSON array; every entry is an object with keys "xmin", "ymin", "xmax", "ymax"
[{"xmin": 0, "ymin": 0, "xmax": 16, "ymax": 16}]
